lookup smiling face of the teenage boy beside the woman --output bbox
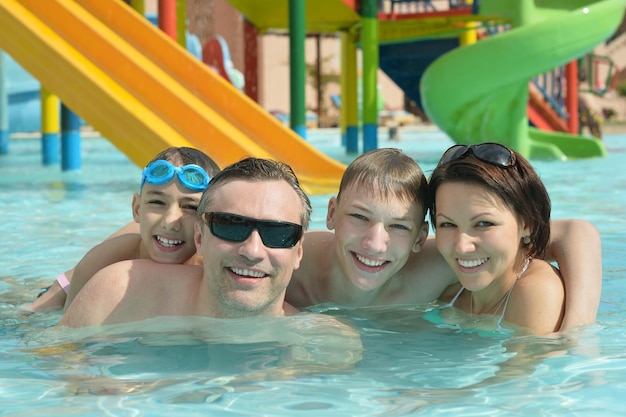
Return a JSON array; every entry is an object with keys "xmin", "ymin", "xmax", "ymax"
[{"xmin": 326, "ymin": 183, "xmax": 428, "ymax": 291}]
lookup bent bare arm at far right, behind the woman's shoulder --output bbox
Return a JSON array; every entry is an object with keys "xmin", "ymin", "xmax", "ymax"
[{"xmin": 546, "ymin": 220, "xmax": 602, "ymax": 331}]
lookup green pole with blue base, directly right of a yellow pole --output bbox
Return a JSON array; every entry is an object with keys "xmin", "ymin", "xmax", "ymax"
[{"xmin": 361, "ymin": 0, "xmax": 378, "ymax": 152}]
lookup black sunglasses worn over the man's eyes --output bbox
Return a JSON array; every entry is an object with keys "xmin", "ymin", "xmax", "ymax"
[{"xmin": 202, "ymin": 213, "xmax": 303, "ymax": 249}]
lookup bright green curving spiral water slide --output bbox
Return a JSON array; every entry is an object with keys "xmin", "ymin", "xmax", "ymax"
[{"xmin": 421, "ymin": 0, "xmax": 626, "ymax": 160}]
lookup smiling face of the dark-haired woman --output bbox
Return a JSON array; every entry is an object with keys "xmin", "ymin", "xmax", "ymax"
[{"xmin": 435, "ymin": 182, "xmax": 529, "ymax": 292}]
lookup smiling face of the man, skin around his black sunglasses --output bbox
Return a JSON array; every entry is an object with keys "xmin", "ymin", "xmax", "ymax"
[{"xmin": 196, "ymin": 179, "xmax": 303, "ymax": 317}]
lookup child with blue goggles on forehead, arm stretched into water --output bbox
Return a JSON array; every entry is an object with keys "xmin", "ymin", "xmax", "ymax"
[{"xmin": 27, "ymin": 147, "xmax": 219, "ymax": 311}]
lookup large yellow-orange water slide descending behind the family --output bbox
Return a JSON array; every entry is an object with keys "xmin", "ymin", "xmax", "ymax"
[{"xmin": 0, "ymin": 0, "xmax": 345, "ymax": 194}]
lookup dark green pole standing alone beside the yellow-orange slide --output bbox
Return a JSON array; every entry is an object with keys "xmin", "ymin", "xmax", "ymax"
[{"xmin": 289, "ymin": 0, "xmax": 306, "ymax": 138}]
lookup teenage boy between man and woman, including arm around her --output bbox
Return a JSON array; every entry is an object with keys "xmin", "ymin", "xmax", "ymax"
[{"xmin": 286, "ymin": 149, "xmax": 602, "ymax": 330}]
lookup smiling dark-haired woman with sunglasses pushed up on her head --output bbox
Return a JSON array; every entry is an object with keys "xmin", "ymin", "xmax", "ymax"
[{"xmin": 430, "ymin": 143, "xmax": 565, "ymax": 334}]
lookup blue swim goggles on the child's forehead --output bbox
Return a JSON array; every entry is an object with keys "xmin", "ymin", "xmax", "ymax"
[{"xmin": 139, "ymin": 159, "xmax": 211, "ymax": 192}]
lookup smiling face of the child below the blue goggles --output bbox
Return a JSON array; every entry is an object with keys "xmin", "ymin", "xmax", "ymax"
[{"xmin": 133, "ymin": 178, "xmax": 202, "ymax": 264}]
